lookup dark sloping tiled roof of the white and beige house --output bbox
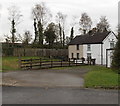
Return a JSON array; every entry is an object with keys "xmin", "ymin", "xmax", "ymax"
[{"xmin": 69, "ymin": 31, "xmax": 110, "ymax": 45}]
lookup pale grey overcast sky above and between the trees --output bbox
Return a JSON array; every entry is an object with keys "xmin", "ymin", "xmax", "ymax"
[{"xmin": 0, "ymin": 0, "xmax": 119, "ymax": 41}]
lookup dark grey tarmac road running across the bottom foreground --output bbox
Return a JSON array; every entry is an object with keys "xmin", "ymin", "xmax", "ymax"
[{"xmin": 2, "ymin": 87, "xmax": 118, "ymax": 104}]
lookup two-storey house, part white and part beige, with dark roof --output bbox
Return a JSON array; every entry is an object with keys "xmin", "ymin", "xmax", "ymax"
[{"xmin": 68, "ymin": 31, "xmax": 117, "ymax": 67}]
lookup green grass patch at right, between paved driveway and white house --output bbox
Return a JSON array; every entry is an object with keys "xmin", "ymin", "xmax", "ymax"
[{"xmin": 84, "ymin": 66, "xmax": 120, "ymax": 88}]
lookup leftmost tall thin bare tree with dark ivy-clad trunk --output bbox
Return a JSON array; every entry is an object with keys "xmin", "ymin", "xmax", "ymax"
[{"xmin": 7, "ymin": 6, "xmax": 22, "ymax": 44}]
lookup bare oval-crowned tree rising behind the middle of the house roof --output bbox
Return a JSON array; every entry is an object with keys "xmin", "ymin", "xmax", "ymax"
[{"xmin": 79, "ymin": 13, "xmax": 92, "ymax": 34}]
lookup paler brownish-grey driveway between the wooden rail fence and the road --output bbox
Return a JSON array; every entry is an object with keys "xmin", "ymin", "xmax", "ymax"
[{"xmin": 3, "ymin": 68, "xmax": 88, "ymax": 87}]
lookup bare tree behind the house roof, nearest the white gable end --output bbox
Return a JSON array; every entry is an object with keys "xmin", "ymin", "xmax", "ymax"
[{"xmin": 97, "ymin": 16, "xmax": 110, "ymax": 32}]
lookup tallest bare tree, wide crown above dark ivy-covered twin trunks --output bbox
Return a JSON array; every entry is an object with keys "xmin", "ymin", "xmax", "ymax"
[{"xmin": 32, "ymin": 2, "xmax": 52, "ymax": 45}]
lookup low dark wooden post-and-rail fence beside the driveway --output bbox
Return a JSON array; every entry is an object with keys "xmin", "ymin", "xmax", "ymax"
[{"xmin": 20, "ymin": 58, "xmax": 84, "ymax": 69}]
